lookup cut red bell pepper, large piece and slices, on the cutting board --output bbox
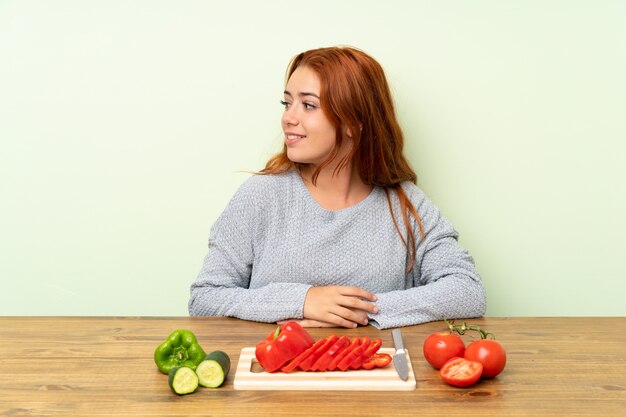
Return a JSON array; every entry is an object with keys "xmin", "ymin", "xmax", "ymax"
[{"xmin": 255, "ymin": 322, "xmax": 391, "ymax": 372}]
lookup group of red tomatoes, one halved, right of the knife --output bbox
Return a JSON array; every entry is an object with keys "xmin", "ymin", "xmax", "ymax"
[{"xmin": 423, "ymin": 320, "xmax": 506, "ymax": 387}]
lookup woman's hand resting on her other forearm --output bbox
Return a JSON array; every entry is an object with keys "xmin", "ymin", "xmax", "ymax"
[{"xmin": 300, "ymin": 286, "xmax": 378, "ymax": 328}]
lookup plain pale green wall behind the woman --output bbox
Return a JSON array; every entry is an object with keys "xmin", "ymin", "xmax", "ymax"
[{"xmin": 0, "ymin": 0, "xmax": 626, "ymax": 316}]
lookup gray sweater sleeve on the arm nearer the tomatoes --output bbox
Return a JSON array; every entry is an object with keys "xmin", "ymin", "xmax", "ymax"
[{"xmin": 370, "ymin": 187, "xmax": 486, "ymax": 329}]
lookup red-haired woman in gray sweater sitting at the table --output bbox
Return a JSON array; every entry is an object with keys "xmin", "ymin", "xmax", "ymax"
[{"xmin": 189, "ymin": 44, "xmax": 486, "ymax": 329}]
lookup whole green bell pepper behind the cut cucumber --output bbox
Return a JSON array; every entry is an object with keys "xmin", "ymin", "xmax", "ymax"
[{"xmin": 154, "ymin": 329, "xmax": 206, "ymax": 374}]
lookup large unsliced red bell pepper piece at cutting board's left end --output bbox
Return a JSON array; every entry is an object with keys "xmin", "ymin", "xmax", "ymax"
[{"xmin": 255, "ymin": 321, "xmax": 315, "ymax": 372}]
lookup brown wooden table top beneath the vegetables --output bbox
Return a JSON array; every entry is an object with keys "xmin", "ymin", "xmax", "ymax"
[{"xmin": 0, "ymin": 317, "xmax": 626, "ymax": 417}]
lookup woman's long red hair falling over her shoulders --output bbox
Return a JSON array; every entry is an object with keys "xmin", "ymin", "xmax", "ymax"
[{"xmin": 260, "ymin": 47, "xmax": 424, "ymax": 272}]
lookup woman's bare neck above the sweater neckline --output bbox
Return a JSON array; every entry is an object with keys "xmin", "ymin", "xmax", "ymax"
[{"xmin": 300, "ymin": 163, "xmax": 372, "ymax": 211}]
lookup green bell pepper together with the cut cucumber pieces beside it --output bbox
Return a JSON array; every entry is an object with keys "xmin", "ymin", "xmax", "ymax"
[{"xmin": 154, "ymin": 329, "xmax": 230, "ymax": 395}]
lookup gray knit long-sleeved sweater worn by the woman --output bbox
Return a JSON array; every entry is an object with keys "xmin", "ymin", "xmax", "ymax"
[{"xmin": 189, "ymin": 170, "xmax": 486, "ymax": 329}]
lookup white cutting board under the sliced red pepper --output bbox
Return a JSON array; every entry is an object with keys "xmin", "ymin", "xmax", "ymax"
[{"xmin": 234, "ymin": 348, "xmax": 415, "ymax": 391}]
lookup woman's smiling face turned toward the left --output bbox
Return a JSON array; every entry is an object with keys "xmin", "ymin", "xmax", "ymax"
[{"xmin": 281, "ymin": 67, "xmax": 336, "ymax": 166}]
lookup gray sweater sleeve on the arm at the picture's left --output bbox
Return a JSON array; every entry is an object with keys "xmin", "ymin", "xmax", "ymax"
[{"xmin": 188, "ymin": 177, "xmax": 310, "ymax": 323}]
